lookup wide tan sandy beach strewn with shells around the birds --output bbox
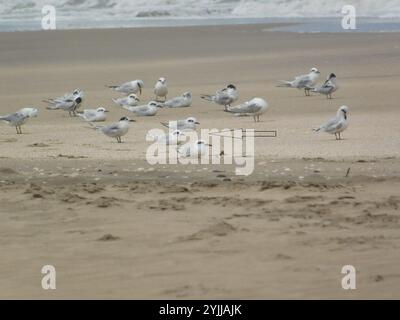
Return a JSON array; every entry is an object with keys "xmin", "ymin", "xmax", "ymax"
[{"xmin": 0, "ymin": 25, "xmax": 400, "ymax": 299}]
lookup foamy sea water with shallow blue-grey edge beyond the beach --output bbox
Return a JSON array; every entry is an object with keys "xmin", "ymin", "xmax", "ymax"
[{"xmin": 0, "ymin": 0, "xmax": 400, "ymax": 32}]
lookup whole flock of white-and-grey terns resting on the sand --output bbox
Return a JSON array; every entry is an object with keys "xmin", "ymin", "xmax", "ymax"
[{"xmin": 0, "ymin": 68, "xmax": 348, "ymax": 152}]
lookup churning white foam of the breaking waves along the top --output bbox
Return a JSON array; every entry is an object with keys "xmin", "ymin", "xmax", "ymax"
[{"xmin": 0, "ymin": 0, "xmax": 400, "ymax": 19}]
